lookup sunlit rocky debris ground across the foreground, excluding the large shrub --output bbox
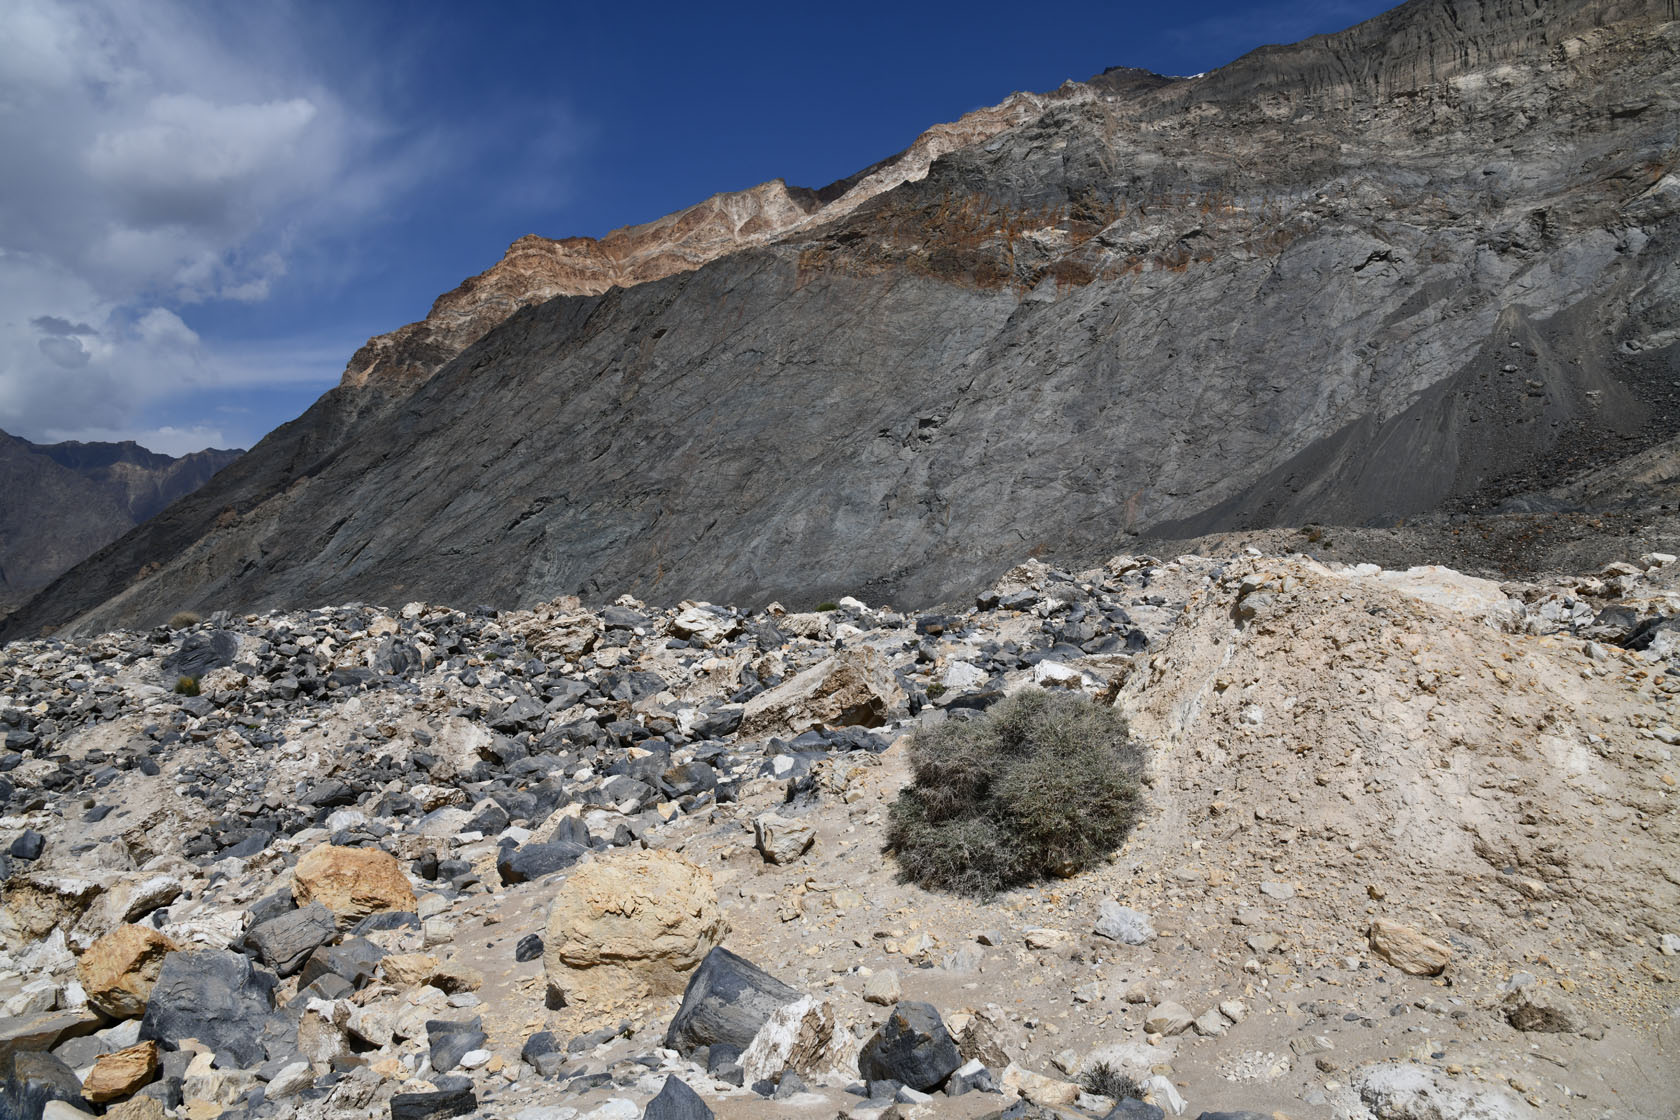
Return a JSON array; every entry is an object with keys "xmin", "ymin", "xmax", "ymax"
[{"xmin": 0, "ymin": 549, "xmax": 1680, "ymax": 1120}]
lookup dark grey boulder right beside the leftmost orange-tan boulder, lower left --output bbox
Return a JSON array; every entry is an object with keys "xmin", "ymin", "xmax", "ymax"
[{"xmin": 139, "ymin": 949, "xmax": 274, "ymax": 1070}]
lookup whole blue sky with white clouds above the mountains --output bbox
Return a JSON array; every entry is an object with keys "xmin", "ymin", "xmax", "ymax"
[{"xmin": 0, "ymin": 0, "xmax": 1389, "ymax": 453}]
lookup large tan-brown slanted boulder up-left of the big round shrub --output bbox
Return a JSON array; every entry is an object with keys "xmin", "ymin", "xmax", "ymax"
[{"xmin": 741, "ymin": 648, "xmax": 906, "ymax": 739}]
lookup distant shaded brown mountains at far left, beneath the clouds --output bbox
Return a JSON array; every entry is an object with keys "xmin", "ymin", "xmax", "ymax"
[{"xmin": 0, "ymin": 432, "xmax": 242, "ymax": 610}]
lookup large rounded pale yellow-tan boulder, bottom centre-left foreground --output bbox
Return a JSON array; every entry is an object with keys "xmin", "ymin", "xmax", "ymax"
[{"xmin": 543, "ymin": 851, "xmax": 729, "ymax": 1019}]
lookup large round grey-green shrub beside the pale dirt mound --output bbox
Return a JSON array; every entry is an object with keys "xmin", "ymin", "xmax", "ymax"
[{"xmin": 887, "ymin": 688, "xmax": 1144, "ymax": 897}]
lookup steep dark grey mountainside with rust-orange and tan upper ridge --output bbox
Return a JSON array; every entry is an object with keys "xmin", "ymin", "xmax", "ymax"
[{"xmin": 10, "ymin": 0, "xmax": 1680, "ymax": 633}]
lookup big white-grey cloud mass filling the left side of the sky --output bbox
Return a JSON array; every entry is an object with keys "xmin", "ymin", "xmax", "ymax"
[{"xmin": 0, "ymin": 0, "xmax": 402, "ymax": 447}]
